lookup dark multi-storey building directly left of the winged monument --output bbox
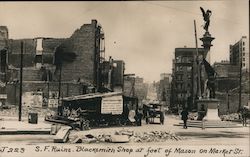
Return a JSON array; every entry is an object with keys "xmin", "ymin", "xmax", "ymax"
[{"xmin": 170, "ymin": 47, "xmax": 206, "ymax": 110}]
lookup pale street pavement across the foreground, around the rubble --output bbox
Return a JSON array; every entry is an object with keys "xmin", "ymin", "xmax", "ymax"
[{"xmin": 0, "ymin": 115, "xmax": 250, "ymax": 145}]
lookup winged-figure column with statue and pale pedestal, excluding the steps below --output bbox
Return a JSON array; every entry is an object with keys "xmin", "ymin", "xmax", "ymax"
[{"xmin": 196, "ymin": 7, "xmax": 220, "ymax": 121}]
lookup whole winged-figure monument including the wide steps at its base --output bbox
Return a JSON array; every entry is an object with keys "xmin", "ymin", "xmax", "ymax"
[{"xmin": 176, "ymin": 7, "xmax": 239, "ymax": 128}]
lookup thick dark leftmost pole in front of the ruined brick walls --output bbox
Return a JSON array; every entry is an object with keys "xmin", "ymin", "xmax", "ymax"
[{"xmin": 18, "ymin": 41, "xmax": 23, "ymax": 121}]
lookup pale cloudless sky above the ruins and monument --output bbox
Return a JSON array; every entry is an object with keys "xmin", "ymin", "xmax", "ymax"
[{"xmin": 0, "ymin": 0, "xmax": 249, "ymax": 82}]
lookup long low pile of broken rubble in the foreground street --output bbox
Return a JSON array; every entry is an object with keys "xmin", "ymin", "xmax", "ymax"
[{"xmin": 69, "ymin": 130, "xmax": 184, "ymax": 143}]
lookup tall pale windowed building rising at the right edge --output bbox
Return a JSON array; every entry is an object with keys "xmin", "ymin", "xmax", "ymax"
[{"xmin": 230, "ymin": 36, "xmax": 249, "ymax": 71}]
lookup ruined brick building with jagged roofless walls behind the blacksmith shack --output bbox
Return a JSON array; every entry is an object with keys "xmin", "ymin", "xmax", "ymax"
[{"xmin": 0, "ymin": 20, "xmax": 124, "ymax": 107}]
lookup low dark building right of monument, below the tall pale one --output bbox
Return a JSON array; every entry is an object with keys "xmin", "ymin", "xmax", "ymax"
[{"xmin": 213, "ymin": 61, "xmax": 250, "ymax": 114}]
